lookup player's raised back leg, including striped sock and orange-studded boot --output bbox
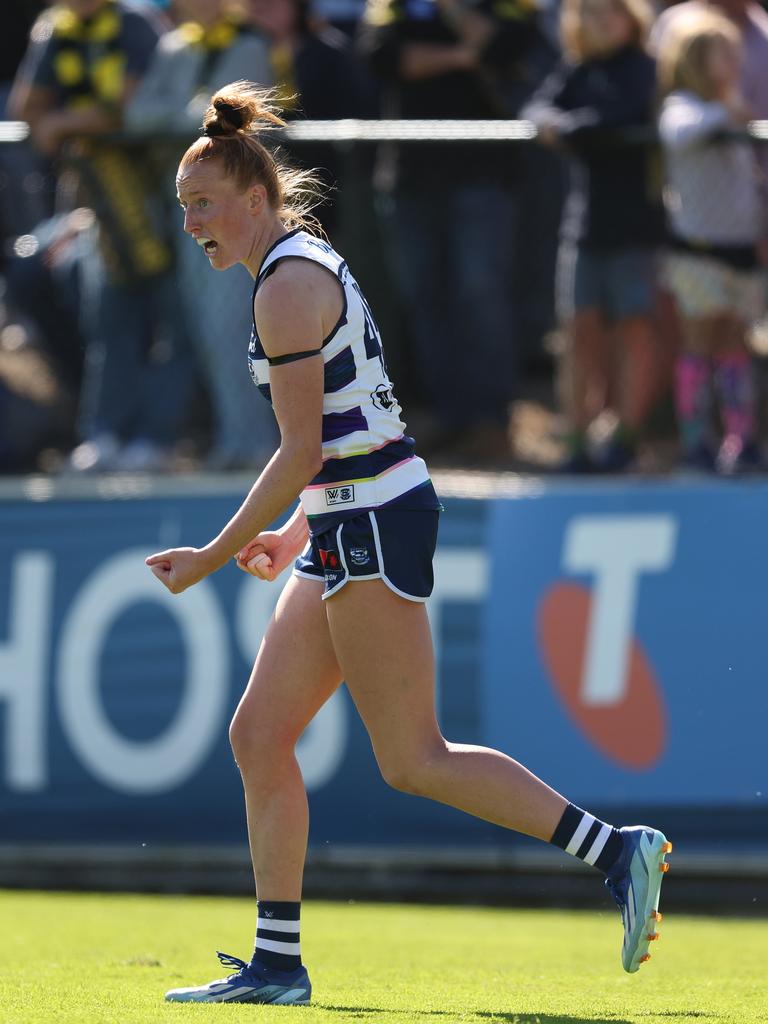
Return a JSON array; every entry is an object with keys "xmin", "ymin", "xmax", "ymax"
[{"xmin": 326, "ymin": 580, "xmax": 672, "ymax": 973}]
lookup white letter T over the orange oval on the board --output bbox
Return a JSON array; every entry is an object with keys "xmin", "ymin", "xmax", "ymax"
[{"xmin": 563, "ymin": 515, "xmax": 677, "ymax": 708}]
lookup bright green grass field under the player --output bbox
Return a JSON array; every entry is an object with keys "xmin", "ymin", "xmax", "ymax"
[{"xmin": 0, "ymin": 892, "xmax": 768, "ymax": 1024}]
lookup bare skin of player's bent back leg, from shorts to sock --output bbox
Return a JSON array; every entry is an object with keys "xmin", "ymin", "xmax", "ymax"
[{"xmin": 326, "ymin": 580, "xmax": 567, "ymax": 841}]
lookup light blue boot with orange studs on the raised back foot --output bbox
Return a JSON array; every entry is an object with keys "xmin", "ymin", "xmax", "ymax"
[{"xmin": 605, "ymin": 825, "xmax": 672, "ymax": 974}]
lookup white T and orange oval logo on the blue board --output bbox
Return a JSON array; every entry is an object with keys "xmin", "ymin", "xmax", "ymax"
[{"xmin": 538, "ymin": 515, "xmax": 677, "ymax": 770}]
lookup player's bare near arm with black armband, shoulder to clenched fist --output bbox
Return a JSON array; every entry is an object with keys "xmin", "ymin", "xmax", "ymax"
[{"xmin": 146, "ymin": 260, "xmax": 341, "ymax": 593}]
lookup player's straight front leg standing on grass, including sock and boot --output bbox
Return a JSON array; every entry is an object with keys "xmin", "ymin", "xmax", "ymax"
[{"xmin": 166, "ymin": 577, "xmax": 341, "ymax": 1005}]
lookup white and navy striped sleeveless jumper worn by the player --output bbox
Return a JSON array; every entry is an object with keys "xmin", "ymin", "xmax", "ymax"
[{"xmin": 248, "ymin": 229, "xmax": 440, "ymax": 534}]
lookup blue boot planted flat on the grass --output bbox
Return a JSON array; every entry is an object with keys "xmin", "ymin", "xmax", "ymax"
[{"xmin": 165, "ymin": 951, "xmax": 312, "ymax": 1007}]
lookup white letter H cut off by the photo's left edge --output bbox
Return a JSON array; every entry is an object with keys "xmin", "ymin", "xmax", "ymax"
[{"xmin": 0, "ymin": 551, "xmax": 53, "ymax": 792}]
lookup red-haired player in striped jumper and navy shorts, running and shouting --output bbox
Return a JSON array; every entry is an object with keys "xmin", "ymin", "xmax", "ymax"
[{"xmin": 146, "ymin": 82, "xmax": 671, "ymax": 1005}]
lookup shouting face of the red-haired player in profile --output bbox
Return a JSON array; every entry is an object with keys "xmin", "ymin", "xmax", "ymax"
[{"xmin": 176, "ymin": 160, "xmax": 265, "ymax": 270}]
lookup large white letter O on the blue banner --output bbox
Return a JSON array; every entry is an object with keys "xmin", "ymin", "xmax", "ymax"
[{"xmin": 58, "ymin": 550, "xmax": 229, "ymax": 793}]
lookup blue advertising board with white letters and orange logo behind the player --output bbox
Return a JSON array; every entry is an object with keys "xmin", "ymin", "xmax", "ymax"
[{"xmin": 0, "ymin": 481, "xmax": 768, "ymax": 847}]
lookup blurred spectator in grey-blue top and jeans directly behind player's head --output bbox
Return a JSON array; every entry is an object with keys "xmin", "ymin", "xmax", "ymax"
[{"xmin": 126, "ymin": 0, "xmax": 275, "ymax": 470}]
